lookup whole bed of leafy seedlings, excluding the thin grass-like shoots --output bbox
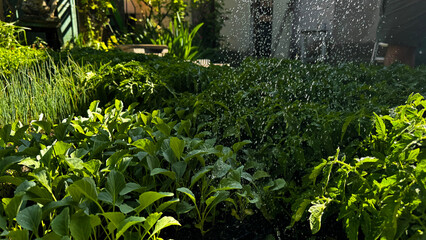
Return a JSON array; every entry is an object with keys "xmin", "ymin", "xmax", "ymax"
[{"xmin": 0, "ymin": 49, "xmax": 426, "ymax": 239}]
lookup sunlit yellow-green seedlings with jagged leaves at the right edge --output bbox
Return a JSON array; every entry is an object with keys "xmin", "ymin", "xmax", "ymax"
[{"xmin": 293, "ymin": 94, "xmax": 426, "ymax": 239}]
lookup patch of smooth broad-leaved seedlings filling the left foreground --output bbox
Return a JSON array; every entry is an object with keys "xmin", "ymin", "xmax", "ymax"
[{"xmin": 0, "ymin": 97, "xmax": 266, "ymax": 239}]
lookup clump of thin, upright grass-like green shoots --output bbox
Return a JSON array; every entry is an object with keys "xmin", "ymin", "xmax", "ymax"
[{"xmin": 0, "ymin": 57, "xmax": 92, "ymax": 125}]
